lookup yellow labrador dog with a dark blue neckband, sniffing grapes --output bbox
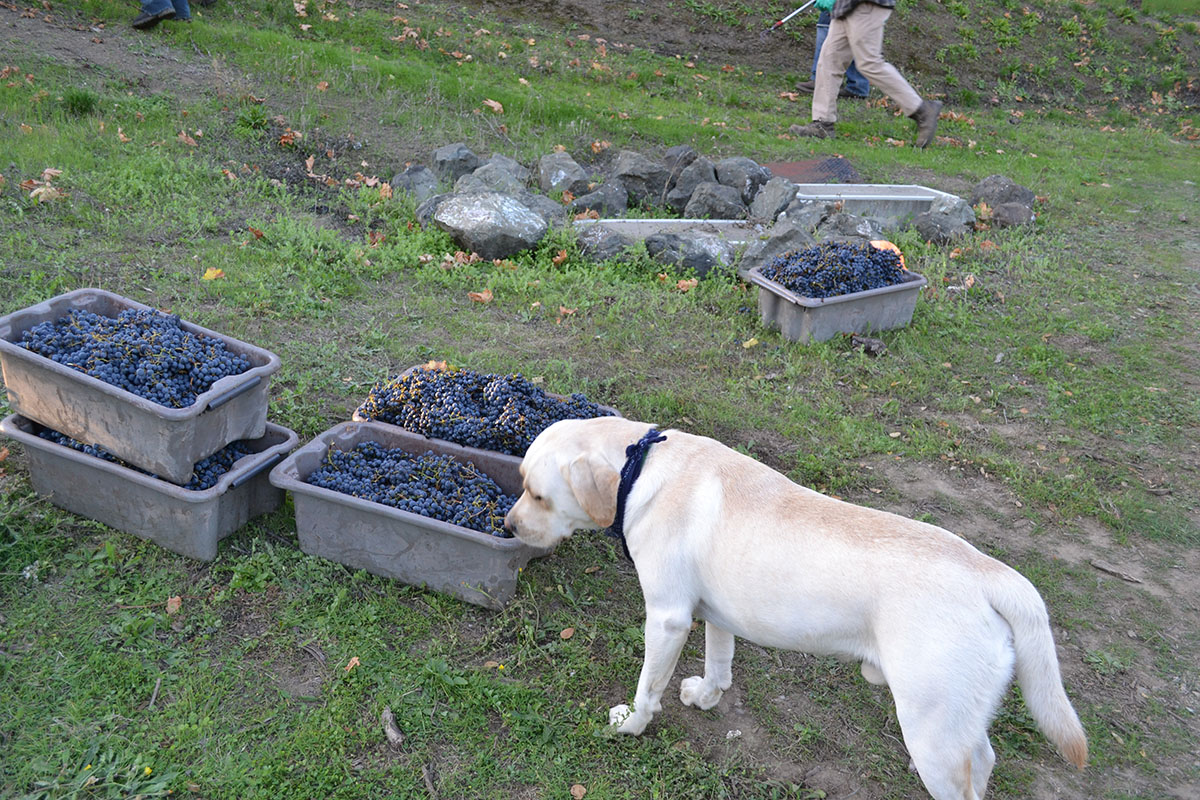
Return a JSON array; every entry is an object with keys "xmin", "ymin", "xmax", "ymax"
[{"xmin": 505, "ymin": 417, "xmax": 1087, "ymax": 800}]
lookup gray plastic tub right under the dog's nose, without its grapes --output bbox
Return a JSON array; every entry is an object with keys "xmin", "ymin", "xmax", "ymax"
[{"xmin": 271, "ymin": 422, "xmax": 548, "ymax": 608}]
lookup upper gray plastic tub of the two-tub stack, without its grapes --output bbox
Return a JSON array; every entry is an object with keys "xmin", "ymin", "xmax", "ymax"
[{"xmin": 0, "ymin": 289, "xmax": 280, "ymax": 483}]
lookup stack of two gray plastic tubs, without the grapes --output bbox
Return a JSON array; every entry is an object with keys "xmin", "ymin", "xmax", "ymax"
[{"xmin": 0, "ymin": 289, "xmax": 298, "ymax": 560}]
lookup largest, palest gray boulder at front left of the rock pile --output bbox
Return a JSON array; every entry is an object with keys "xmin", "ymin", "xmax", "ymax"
[{"xmin": 433, "ymin": 192, "xmax": 547, "ymax": 260}]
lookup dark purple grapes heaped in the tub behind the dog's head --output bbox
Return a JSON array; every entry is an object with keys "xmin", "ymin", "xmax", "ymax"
[{"xmin": 358, "ymin": 368, "xmax": 612, "ymax": 456}]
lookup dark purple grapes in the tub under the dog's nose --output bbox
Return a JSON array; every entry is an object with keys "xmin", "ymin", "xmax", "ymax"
[{"xmin": 307, "ymin": 441, "xmax": 516, "ymax": 537}]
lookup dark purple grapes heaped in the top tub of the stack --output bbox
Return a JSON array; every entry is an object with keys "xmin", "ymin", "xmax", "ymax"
[{"xmin": 19, "ymin": 308, "xmax": 250, "ymax": 408}]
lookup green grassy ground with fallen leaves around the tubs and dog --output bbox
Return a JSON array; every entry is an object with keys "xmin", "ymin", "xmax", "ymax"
[{"xmin": 0, "ymin": 0, "xmax": 1200, "ymax": 799}]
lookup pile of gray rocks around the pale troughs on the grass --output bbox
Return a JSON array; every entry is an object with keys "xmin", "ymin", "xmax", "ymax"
[{"xmin": 391, "ymin": 142, "xmax": 1036, "ymax": 276}]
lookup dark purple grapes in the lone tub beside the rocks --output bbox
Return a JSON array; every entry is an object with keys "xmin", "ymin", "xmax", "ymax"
[{"xmin": 762, "ymin": 242, "xmax": 908, "ymax": 299}]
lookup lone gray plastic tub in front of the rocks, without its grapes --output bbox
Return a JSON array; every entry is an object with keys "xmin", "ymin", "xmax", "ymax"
[{"xmin": 746, "ymin": 266, "xmax": 926, "ymax": 342}]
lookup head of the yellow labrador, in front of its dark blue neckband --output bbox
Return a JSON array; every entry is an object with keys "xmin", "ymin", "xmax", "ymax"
[{"xmin": 504, "ymin": 417, "xmax": 647, "ymax": 547}]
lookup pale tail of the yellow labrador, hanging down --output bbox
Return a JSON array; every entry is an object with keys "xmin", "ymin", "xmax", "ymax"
[{"xmin": 988, "ymin": 570, "xmax": 1087, "ymax": 769}]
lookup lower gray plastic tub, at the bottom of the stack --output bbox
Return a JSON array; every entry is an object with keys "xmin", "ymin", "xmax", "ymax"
[{"xmin": 0, "ymin": 414, "xmax": 300, "ymax": 561}]
